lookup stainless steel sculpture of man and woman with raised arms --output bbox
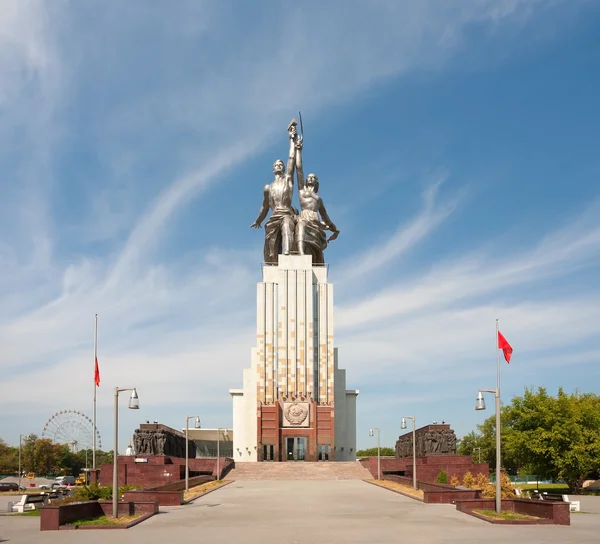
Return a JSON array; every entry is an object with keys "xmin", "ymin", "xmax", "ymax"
[{"xmin": 250, "ymin": 119, "xmax": 339, "ymax": 265}]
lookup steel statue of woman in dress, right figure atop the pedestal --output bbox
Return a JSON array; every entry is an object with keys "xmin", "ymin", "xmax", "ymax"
[{"xmin": 295, "ymin": 135, "xmax": 340, "ymax": 265}]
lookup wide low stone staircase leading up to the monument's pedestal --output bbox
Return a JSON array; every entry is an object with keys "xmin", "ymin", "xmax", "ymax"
[{"xmin": 225, "ymin": 461, "xmax": 373, "ymax": 480}]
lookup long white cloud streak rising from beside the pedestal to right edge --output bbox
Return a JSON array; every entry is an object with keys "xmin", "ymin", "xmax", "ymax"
[{"xmin": 337, "ymin": 198, "xmax": 600, "ymax": 327}]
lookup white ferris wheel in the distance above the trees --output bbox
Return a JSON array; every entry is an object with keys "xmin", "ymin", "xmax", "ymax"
[{"xmin": 42, "ymin": 410, "xmax": 102, "ymax": 453}]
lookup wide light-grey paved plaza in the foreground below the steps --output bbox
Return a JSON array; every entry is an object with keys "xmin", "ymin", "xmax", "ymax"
[{"xmin": 0, "ymin": 480, "xmax": 600, "ymax": 544}]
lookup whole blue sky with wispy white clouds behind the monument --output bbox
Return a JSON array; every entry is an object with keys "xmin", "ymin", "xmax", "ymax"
[{"xmin": 0, "ymin": 0, "xmax": 600, "ymax": 449}]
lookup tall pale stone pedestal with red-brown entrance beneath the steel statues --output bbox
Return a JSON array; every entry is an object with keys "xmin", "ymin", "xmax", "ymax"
[{"xmin": 229, "ymin": 255, "xmax": 358, "ymax": 461}]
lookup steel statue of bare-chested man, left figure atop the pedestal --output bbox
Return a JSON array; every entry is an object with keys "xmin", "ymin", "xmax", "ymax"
[{"xmin": 250, "ymin": 119, "xmax": 298, "ymax": 265}]
